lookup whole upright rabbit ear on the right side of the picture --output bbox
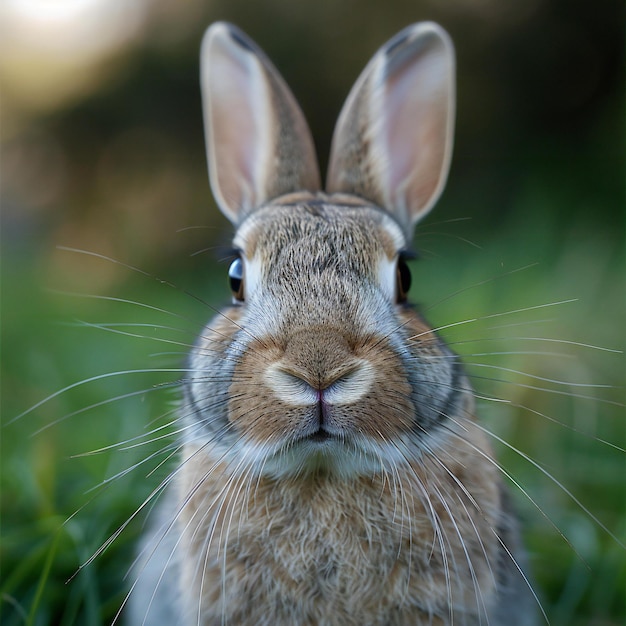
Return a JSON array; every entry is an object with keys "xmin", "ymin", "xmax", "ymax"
[{"xmin": 326, "ymin": 22, "xmax": 455, "ymax": 236}]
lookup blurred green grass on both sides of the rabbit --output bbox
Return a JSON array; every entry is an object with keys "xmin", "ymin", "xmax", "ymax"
[{"xmin": 0, "ymin": 207, "xmax": 626, "ymax": 626}]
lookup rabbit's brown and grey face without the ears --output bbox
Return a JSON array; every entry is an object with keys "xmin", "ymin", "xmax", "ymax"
[{"xmin": 183, "ymin": 197, "xmax": 460, "ymax": 476}]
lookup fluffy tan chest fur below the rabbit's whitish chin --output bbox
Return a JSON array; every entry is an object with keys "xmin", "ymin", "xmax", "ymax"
[{"xmin": 178, "ymin": 428, "xmax": 500, "ymax": 625}]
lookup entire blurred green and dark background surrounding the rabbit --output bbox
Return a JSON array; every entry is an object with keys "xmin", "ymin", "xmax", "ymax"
[{"xmin": 0, "ymin": 0, "xmax": 626, "ymax": 626}]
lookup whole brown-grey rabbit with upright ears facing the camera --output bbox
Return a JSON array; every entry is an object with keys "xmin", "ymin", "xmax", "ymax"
[{"xmin": 128, "ymin": 22, "xmax": 538, "ymax": 626}]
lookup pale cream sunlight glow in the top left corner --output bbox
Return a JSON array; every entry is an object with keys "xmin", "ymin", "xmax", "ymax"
[{"xmin": 0, "ymin": 0, "xmax": 153, "ymax": 117}]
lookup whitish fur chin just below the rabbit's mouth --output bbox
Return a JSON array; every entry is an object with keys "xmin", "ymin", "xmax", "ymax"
[{"xmin": 233, "ymin": 436, "xmax": 415, "ymax": 480}]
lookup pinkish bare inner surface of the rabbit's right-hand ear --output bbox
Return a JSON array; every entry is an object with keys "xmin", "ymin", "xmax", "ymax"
[{"xmin": 383, "ymin": 52, "xmax": 449, "ymax": 212}]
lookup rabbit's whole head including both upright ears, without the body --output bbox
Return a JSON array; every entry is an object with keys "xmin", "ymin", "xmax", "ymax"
[{"xmin": 187, "ymin": 23, "xmax": 471, "ymax": 475}]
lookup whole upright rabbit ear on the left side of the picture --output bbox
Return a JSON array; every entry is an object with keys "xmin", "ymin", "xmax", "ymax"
[{"xmin": 200, "ymin": 22, "xmax": 320, "ymax": 225}]
